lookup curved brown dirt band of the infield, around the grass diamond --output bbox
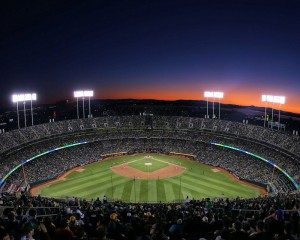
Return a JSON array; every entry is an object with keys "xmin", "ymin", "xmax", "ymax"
[{"xmin": 110, "ymin": 163, "xmax": 186, "ymax": 179}]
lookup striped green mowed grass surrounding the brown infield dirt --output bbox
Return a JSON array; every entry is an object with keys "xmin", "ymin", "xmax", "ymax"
[{"xmin": 38, "ymin": 154, "xmax": 259, "ymax": 202}]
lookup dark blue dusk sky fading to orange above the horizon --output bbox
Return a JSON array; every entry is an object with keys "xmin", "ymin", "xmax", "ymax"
[{"xmin": 0, "ymin": 0, "xmax": 300, "ymax": 113}]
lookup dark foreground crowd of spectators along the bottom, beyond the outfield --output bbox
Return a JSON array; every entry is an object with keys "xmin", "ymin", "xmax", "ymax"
[{"xmin": 0, "ymin": 190, "xmax": 300, "ymax": 240}]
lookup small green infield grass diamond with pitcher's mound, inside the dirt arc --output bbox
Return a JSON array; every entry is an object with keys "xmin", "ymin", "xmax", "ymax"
[{"xmin": 128, "ymin": 158, "xmax": 168, "ymax": 172}]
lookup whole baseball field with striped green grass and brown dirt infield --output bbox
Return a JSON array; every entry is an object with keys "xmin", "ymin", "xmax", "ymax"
[{"xmin": 31, "ymin": 154, "xmax": 263, "ymax": 202}]
